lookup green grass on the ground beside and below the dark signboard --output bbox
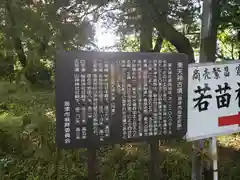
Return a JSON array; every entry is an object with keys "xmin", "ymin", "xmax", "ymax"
[{"xmin": 0, "ymin": 82, "xmax": 240, "ymax": 180}]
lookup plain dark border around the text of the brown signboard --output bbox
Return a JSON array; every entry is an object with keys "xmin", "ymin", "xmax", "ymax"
[{"xmin": 55, "ymin": 51, "xmax": 188, "ymax": 148}]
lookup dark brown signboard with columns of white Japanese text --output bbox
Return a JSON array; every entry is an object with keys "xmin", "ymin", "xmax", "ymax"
[{"xmin": 56, "ymin": 51, "xmax": 188, "ymax": 148}]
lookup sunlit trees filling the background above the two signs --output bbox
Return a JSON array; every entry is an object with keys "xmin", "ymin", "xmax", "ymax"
[{"xmin": 0, "ymin": 0, "xmax": 240, "ymax": 83}]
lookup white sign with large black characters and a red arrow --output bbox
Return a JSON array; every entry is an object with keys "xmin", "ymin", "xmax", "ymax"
[{"xmin": 186, "ymin": 61, "xmax": 240, "ymax": 141}]
